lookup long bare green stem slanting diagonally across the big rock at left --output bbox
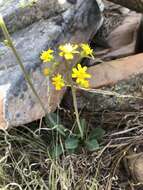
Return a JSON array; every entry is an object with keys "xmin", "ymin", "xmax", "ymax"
[{"xmin": 0, "ymin": 16, "xmax": 55, "ymax": 125}]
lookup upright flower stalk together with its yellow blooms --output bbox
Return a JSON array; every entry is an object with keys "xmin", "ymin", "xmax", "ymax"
[{"xmin": 40, "ymin": 43, "xmax": 93, "ymax": 139}]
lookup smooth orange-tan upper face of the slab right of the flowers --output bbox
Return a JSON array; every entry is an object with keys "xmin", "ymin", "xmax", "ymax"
[{"xmin": 88, "ymin": 53, "xmax": 143, "ymax": 89}]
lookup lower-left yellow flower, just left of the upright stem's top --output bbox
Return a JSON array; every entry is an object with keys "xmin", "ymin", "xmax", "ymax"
[{"xmin": 52, "ymin": 74, "xmax": 65, "ymax": 90}]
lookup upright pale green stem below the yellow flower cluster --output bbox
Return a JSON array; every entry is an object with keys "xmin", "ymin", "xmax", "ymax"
[{"xmin": 71, "ymin": 86, "xmax": 83, "ymax": 139}]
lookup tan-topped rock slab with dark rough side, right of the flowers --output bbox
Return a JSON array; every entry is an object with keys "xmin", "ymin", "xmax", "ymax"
[{"xmin": 64, "ymin": 53, "xmax": 143, "ymax": 125}]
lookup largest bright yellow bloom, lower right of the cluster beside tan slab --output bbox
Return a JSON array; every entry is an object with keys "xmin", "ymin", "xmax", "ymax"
[{"xmin": 72, "ymin": 64, "xmax": 91, "ymax": 88}]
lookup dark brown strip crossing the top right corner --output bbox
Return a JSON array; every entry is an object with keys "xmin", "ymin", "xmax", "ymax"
[{"xmin": 108, "ymin": 0, "xmax": 143, "ymax": 13}]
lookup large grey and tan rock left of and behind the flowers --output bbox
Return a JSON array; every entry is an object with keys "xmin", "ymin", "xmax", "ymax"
[{"xmin": 0, "ymin": 0, "xmax": 103, "ymax": 128}]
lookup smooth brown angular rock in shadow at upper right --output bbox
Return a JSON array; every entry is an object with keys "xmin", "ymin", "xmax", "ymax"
[{"xmin": 103, "ymin": 12, "xmax": 142, "ymax": 60}]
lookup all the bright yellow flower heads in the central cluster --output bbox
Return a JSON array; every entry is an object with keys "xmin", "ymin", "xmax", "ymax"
[{"xmin": 40, "ymin": 43, "xmax": 94, "ymax": 90}]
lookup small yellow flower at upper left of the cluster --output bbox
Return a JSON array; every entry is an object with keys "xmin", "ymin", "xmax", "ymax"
[{"xmin": 40, "ymin": 49, "xmax": 54, "ymax": 63}]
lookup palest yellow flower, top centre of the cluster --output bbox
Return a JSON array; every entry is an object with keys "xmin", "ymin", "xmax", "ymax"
[{"xmin": 59, "ymin": 43, "xmax": 79, "ymax": 60}]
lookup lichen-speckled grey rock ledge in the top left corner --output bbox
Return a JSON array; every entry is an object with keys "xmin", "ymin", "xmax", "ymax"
[{"xmin": 0, "ymin": 0, "xmax": 70, "ymax": 35}]
